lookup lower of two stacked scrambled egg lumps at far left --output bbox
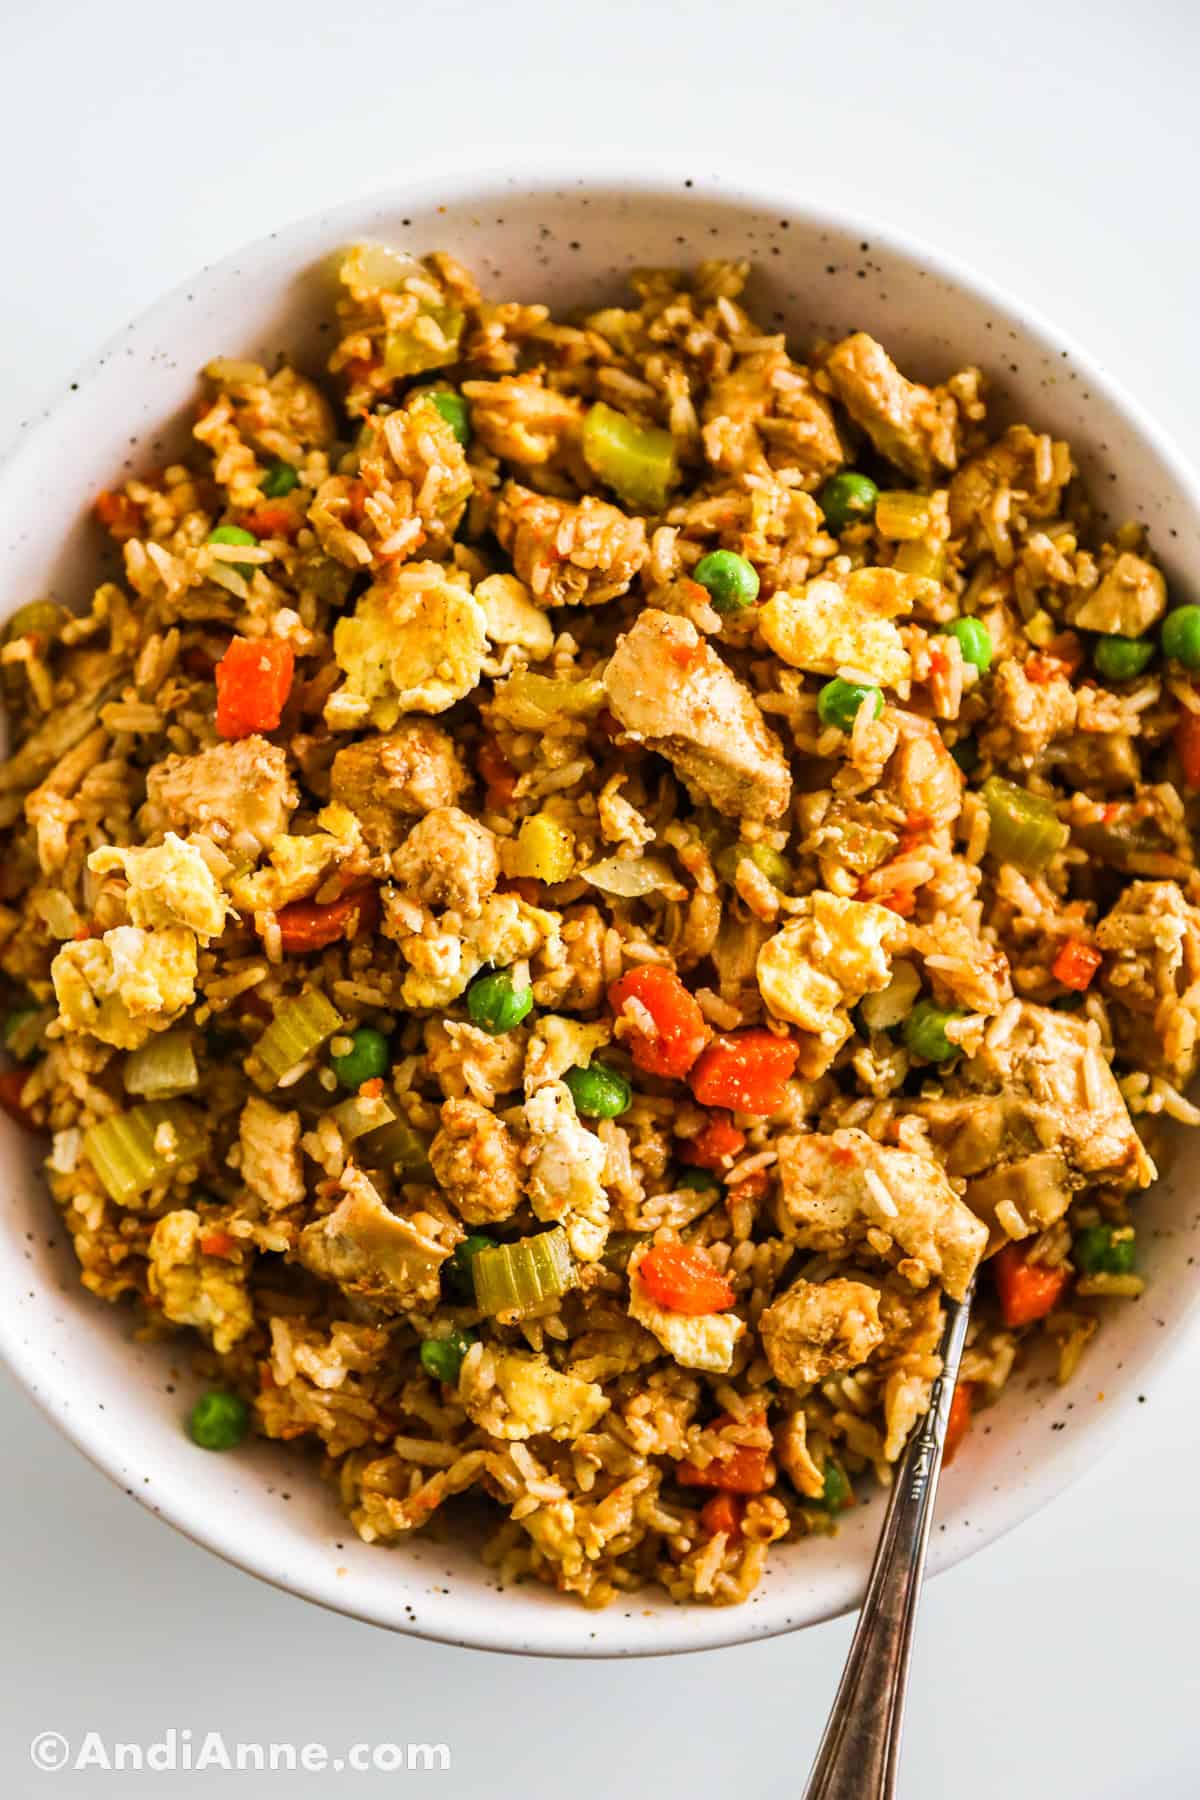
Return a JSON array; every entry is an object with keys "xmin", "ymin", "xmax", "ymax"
[{"xmin": 50, "ymin": 925, "xmax": 196, "ymax": 1049}]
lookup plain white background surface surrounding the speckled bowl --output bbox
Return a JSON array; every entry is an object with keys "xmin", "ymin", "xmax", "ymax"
[{"xmin": 0, "ymin": 0, "xmax": 1200, "ymax": 1800}]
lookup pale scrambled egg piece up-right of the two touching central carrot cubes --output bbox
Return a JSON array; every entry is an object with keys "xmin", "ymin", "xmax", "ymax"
[{"xmin": 757, "ymin": 887, "xmax": 909, "ymax": 1044}]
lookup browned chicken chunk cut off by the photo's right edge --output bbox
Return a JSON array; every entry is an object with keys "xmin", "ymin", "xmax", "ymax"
[{"xmin": 1096, "ymin": 882, "xmax": 1200, "ymax": 1087}]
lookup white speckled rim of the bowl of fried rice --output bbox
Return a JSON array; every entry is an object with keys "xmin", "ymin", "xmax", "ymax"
[{"xmin": 0, "ymin": 149, "xmax": 1200, "ymax": 1660}]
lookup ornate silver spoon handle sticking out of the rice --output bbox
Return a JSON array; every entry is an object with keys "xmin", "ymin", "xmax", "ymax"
[{"xmin": 804, "ymin": 1289, "xmax": 972, "ymax": 1800}]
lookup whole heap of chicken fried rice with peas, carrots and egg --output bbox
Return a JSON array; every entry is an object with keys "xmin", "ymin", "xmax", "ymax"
[{"xmin": 0, "ymin": 245, "xmax": 1200, "ymax": 1606}]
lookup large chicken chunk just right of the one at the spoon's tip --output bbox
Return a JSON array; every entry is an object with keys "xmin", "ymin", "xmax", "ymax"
[{"xmin": 959, "ymin": 1004, "xmax": 1153, "ymax": 1186}]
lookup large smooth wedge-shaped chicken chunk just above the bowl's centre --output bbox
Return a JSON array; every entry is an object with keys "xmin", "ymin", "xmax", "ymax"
[{"xmin": 604, "ymin": 608, "xmax": 792, "ymax": 819}]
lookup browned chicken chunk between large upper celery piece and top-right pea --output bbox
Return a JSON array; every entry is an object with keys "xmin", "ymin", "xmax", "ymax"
[{"xmin": 703, "ymin": 349, "xmax": 846, "ymax": 481}]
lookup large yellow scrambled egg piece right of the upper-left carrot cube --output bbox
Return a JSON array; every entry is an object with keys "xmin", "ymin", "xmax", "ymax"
[{"xmin": 326, "ymin": 563, "xmax": 488, "ymax": 731}]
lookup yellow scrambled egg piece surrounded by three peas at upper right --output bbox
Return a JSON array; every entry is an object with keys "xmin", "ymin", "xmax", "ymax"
[{"xmin": 757, "ymin": 569, "xmax": 918, "ymax": 688}]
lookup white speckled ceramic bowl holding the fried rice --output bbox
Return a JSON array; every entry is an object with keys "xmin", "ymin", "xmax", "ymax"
[{"xmin": 0, "ymin": 167, "xmax": 1200, "ymax": 1656}]
